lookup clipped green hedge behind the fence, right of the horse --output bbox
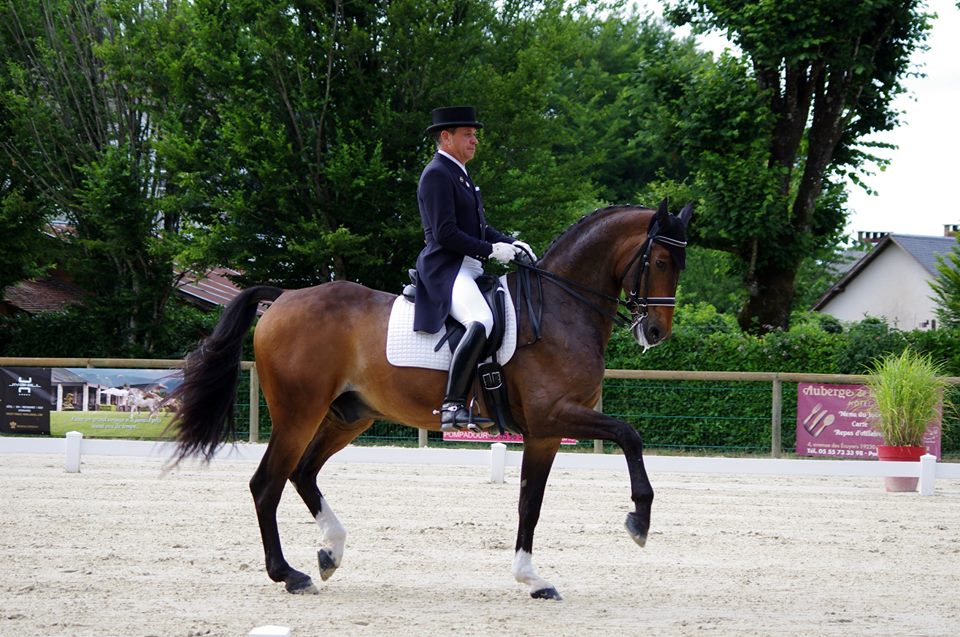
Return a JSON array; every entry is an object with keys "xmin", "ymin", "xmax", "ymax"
[{"xmin": 603, "ymin": 304, "xmax": 960, "ymax": 453}]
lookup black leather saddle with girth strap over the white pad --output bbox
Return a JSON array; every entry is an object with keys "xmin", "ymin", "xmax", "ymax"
[{"xmin": 402, "ymin": 268, "xmax": 521, "ymax": 434}]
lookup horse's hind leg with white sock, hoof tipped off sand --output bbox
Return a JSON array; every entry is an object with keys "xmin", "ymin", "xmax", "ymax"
[{"xmin": 290, "ymin": 415, "xmax": 373, "ymax": 581}]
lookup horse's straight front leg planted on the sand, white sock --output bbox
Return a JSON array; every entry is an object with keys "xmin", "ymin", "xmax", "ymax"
[{"xmin": 513, "ymin": 438, "xmax": 561, "ymax": 599}]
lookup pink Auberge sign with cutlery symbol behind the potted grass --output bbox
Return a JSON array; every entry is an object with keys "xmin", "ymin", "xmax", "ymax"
[{"xmin": 796, "ymin": 383, "xmax": 940, "ymax": 460}]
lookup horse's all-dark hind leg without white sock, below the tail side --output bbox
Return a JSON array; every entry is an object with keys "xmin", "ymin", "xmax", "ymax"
[{"xmin": 250, "ymin": 419, "xmax": 317, "ymax": 593}]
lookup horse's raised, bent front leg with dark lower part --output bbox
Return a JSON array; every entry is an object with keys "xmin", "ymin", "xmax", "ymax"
[{"xmin": 557, "ymin": 405, "xmax": 653, "ymax": 546}]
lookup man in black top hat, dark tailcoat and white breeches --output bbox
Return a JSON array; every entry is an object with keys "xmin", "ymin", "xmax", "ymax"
[{"xmin": 413, "ymin": 106, "xmax": 536, "ymax": 431}]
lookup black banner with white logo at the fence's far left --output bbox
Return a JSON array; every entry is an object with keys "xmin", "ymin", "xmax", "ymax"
[{"xmin": 0, "ymin": 367, "xmax": 52, "ymax": 436}]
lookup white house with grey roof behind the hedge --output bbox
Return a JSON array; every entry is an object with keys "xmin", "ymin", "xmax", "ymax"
[{"xmin": 812, "ymin": 230, "xmax": 957, "ymax": 330}]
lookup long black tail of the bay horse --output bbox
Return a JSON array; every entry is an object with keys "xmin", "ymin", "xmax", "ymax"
[{"xmin": 168, "ymin": 286, "xmax": 283, "ymax": 464}]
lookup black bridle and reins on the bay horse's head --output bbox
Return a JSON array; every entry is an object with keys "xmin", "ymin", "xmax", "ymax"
[{"xmin": 514, "ymin": 217, "xmax": 687, "ymax": 345}]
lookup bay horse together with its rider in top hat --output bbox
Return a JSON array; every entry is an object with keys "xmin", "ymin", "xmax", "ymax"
[{"xmin": 165, "ymin": 107, "xmax": 692, "ymax": 599}]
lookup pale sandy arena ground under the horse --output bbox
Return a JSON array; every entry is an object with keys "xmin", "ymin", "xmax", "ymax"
[{"xmin": 0, "ymin": 454, "xmax": 960, "ymax": 637}]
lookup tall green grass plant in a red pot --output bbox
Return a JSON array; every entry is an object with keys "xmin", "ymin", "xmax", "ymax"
[{"xmin": 867, "ymin": 347, "xmax": 947, "ymax": 491}]
